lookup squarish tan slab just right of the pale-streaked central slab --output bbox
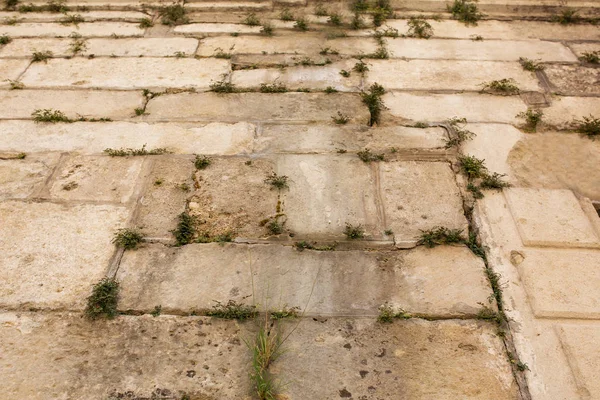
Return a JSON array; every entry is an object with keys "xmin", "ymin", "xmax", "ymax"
[{"xmin": 379, "ymin": 161, "xmax": 467, "ymax": 243}]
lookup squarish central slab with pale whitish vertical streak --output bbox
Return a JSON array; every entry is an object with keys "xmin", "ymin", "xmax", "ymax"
[{"xmin": 277, "ymin": 155, "xmax": 386, "ymax": 239}]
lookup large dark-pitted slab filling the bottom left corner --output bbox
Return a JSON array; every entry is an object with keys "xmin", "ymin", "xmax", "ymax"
[{"xmin": 0, "ymin": 313, "xmax": 252, "ymax": 400}]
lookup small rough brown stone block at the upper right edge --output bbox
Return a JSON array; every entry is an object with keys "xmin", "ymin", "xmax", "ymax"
[{"xmin": 544, "ymin": 64, "xmax": 600, "ymax": 95}]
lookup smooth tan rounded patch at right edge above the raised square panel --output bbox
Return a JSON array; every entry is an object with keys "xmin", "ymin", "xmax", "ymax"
[{"xmin": 508, "ymin": 132, "xmax": 600, "ymax": 201}]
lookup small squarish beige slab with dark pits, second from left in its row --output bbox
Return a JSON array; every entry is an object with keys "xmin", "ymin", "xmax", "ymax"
[{"xmin": 49, "ymin": 156, "xmax": 144, "ymax": 203}]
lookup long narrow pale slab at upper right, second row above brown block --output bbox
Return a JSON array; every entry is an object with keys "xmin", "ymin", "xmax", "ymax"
[{"xmin": 386, "ymin": 39, "xmax": 577, "ymax": 62}]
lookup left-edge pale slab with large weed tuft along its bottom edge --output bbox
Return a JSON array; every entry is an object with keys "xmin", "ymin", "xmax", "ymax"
[{"xmin": 0, "ymin": 90, "xmax": 144, "ymax": 119}]
